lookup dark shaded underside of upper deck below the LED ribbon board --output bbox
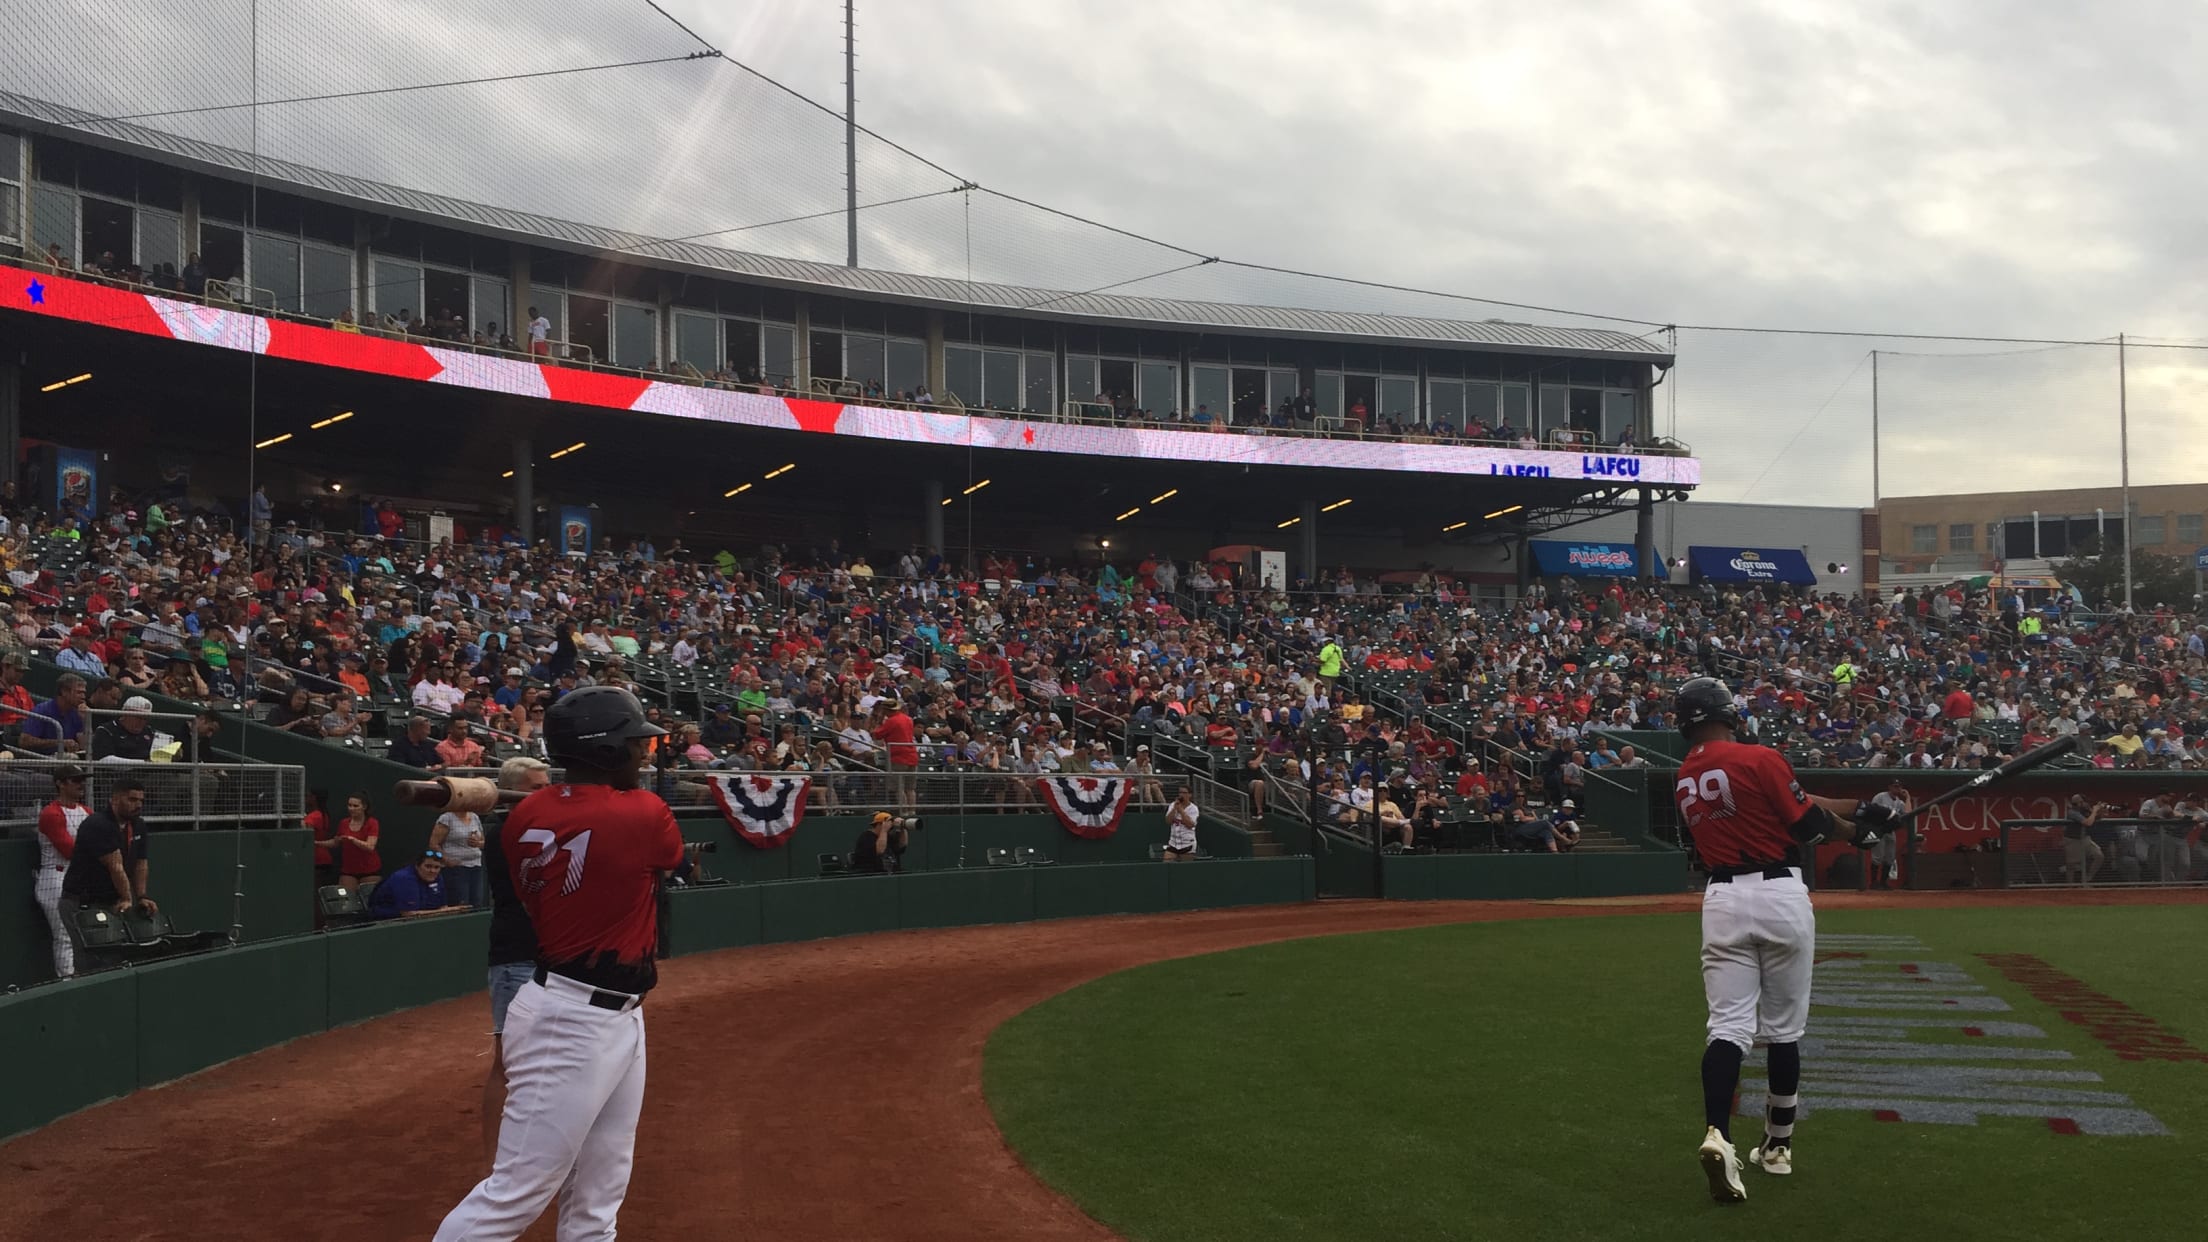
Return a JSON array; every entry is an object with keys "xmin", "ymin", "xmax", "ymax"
[{"xmin": 0, "ymin": 287, "xmax": 1687, "ymax": 550}]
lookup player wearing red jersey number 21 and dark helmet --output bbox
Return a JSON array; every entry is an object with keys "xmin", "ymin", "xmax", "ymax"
[{"xmin": 437, "ymin": 685, "xmax": 682, "ymax": 1242}]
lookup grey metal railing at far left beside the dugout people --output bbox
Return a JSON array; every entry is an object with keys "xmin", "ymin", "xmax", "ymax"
[{"xmin": 0, "ymin": 758, "xmax": 307, "ymax": 835}]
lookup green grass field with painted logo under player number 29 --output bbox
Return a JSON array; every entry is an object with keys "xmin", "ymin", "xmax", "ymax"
[{"xmin": 983, "ymin": 906, "xmax": 2208, "ymax": 1242}]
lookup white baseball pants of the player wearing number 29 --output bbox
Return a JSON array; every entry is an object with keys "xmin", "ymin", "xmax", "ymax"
[{"xmin": 1702, "ymin": 873, "xmax": 1817, "ymax": 1050}]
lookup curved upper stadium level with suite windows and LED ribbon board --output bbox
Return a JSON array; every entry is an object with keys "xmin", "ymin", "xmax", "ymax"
[{"xmin": 0, "ymin": 116, "xmax": 1698, "ymax": 575}]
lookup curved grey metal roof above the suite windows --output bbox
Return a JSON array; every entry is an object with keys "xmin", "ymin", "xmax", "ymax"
[{"xmin": 0, "ymin": 91, "xmax": 1671, "ymax": 367}]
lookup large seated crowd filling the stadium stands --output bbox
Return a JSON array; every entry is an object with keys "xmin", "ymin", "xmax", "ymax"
[{"xmin": 0, "ymin": 479, "xmax": 2208, "ymax": 866}]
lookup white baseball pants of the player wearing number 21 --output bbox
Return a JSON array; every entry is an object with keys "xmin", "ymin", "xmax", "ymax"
[{"xmin": 435, "ymin": 975, "xmax": 645, "ymax": 1242}]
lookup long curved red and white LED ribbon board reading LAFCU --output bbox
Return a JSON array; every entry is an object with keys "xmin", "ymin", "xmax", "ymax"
[{"xmin": 0, "ymin": 265, "xmax": 1702, "ymax": 486}]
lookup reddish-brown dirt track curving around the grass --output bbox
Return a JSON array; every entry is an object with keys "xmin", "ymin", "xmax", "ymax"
[{"xmin": 0, "ymin": 891, "xmax": 2204, "ymax": 1242}]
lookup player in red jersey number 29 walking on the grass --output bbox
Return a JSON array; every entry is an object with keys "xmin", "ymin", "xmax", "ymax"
[{"xmin": 1674, "ymin": 676, "xmax": 1892, "ymax": 1202}]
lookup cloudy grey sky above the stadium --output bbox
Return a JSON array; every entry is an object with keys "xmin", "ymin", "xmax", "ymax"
[{"xmin": 17, "ymin": 0, "xmax": 2208, "ymax": 504}]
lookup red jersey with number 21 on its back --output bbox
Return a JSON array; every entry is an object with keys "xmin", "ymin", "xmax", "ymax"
[{"xmin": 499, "ymin": 785, "xmax": 682, "ymax": 994}]
